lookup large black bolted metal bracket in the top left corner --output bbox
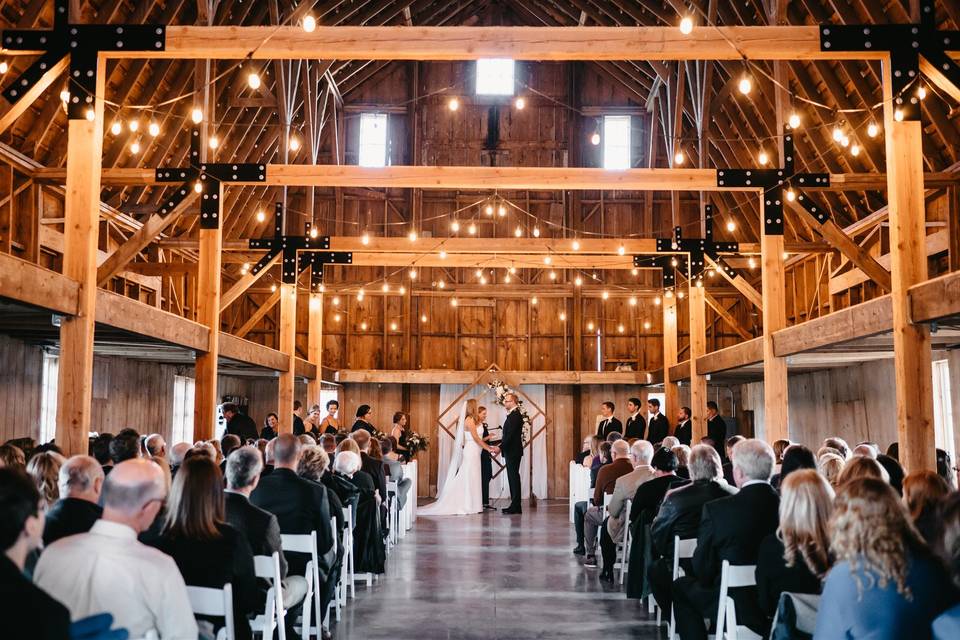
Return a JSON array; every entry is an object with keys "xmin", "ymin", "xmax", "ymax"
[{"xmin": 0, "ymin": 0, "xmax": 167, "ymax": 120}]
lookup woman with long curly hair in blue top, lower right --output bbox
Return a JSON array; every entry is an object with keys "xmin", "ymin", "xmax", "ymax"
[{"xmin": 812, "ymin": 478, "xmax": 956, "ymax": 640}]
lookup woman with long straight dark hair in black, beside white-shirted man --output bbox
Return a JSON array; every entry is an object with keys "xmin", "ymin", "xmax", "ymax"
[{"xmin": 156, "ymin": 456, "xmax": 263, "ymax": 640}]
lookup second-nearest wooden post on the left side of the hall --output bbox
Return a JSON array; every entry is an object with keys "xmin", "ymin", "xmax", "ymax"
[{"xmin": 193, "ymin": 210, "xmax": 223, "ymax": 440}]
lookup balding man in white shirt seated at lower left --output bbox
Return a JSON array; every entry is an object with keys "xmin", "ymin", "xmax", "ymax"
[{"xmin": 34, "ymin": 459, "xmax": 197, "ymax": 640}]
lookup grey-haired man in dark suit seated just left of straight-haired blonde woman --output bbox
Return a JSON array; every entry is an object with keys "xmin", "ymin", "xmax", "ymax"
[{"xmin": 673, "ymin": 440, "xmax": 780, "ymax": 640}]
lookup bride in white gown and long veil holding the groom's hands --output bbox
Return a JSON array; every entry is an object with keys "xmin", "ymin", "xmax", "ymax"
[{"xmin": 417, "ymin": 398, "xmax": 499, "ymax": 516}]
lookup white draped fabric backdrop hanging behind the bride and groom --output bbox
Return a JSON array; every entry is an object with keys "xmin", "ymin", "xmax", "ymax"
[{"xmin": 437, "ymin": 384, "xmax": 547, "ymax": 500}]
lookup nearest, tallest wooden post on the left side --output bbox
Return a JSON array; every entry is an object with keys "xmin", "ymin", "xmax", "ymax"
[{"xmin": 55, "ymin": 62, "xmax": 106, "ymax": 456}]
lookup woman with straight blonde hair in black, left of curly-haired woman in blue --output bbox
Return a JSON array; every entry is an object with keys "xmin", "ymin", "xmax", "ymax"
[{"xmin": 757, "ymin": 468, "xmax": 833, "ymax": 628}]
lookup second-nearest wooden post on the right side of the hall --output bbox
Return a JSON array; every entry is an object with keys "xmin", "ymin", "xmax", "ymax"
[{"xmin": 760, "ymin": 202, "xmax": 787, "ymax": 443}]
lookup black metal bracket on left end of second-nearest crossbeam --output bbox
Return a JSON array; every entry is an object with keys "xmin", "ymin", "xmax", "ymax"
[{"xmin": 154, "ymin": 127, "xmax": 267, "ymax": 229}]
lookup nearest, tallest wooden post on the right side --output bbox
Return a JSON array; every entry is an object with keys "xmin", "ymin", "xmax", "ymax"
[{"xmin": 883, "ymin": 59, "xmax": 936, "ymax": 473}]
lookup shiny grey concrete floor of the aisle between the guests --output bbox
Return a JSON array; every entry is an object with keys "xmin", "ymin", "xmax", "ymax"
[{"xmin": 333, "ymin": 501, "xmax": 666, "ymax": 640}]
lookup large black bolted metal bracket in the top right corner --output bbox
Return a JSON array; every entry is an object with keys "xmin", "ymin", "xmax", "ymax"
[{"xmin": 820, "ymin": 0, "xmax": 960, "ymax": 120}]
